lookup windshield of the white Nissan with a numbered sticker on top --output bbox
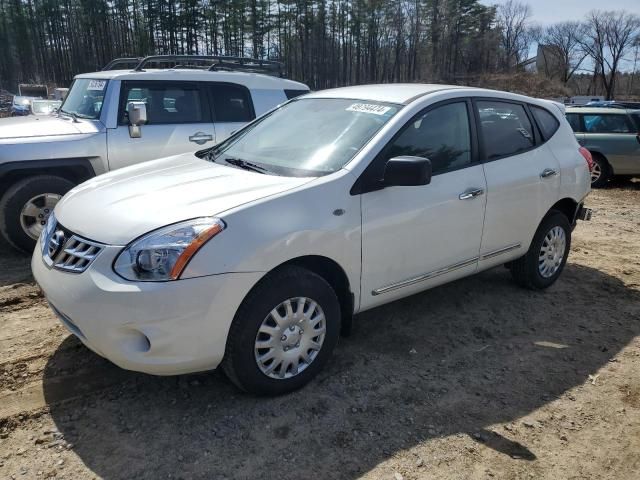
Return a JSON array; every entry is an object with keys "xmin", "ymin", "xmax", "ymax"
[{"xmin": 209, "ymin": 98, "xmax": 400, "ymax": 176}]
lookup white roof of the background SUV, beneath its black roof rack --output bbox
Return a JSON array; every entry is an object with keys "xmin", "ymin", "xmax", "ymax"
[{"xmin": 75, "ymin": 68, "xmax": 309, "ymax": 90}]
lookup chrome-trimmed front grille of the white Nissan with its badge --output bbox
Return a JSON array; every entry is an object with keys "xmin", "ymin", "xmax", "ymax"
[{"xmin": 41, "ymin": 215, "xmax": 104, "ymax": 273}]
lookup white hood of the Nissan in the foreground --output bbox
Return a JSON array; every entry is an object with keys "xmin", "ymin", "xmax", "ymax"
[{"xmin": 55, "ymin": 154, "xmax": 313, "ymax": 245}]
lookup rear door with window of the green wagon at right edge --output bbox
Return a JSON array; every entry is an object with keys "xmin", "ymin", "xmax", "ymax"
[{"xmin": 581, "ymin": 111, "xmax": 640, "ymax": 174}]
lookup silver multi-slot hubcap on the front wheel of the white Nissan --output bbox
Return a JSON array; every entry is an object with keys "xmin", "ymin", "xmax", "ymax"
[{"xmin": 254, "ymin": 297, "xmax": 327, "ymax": 380}]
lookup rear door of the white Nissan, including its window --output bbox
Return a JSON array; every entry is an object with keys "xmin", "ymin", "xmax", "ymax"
[{"xmin": 474, "ymin": 99, "xmax": 560, "ymax": 269}]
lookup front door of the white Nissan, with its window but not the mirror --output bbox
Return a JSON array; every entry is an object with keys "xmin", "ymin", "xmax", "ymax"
[{"xmin": 361, "ymin": 100, "xmax": 486, "ymax": 310}]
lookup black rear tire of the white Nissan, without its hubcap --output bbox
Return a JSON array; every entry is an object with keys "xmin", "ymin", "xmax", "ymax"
[{"xmin": 510, "ymin": 210, "xmax": 571, "ymax": 290}]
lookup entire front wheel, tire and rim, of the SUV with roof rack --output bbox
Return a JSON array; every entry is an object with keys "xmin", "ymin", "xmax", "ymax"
[{"xmin": 0, "ymin": 175, "xmax": 74, "ymax": 253}]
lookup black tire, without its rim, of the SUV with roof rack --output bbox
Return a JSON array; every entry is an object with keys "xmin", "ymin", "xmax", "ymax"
[{"xmin": 0, "ymin": 175, "xmax": 75, "ymax": 253}]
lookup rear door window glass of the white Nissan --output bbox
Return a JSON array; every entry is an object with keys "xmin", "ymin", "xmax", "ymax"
[{"xmin": 476, "ymin": 101, "xmax": 535, "ymax": 160}]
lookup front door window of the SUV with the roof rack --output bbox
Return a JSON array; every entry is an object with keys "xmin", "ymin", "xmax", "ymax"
[{"xmin": 119, "ymin": 81, "xmax": 210, "ymax": 125}]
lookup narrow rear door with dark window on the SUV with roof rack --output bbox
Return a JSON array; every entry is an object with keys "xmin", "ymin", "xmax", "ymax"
[{"xmin": 207, "ymin": 83, "xmax": 255, "ymax": 143}]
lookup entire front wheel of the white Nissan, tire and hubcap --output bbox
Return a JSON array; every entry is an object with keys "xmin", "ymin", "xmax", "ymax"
[{"xmin": 222, "ymin": 266, "xmax": 340, "ymax": 395}]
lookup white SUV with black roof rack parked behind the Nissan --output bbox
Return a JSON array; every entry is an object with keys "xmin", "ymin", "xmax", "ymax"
[{"xmin": 0, "ymin": 55, "xmax": 309, "ymax": 251}]
